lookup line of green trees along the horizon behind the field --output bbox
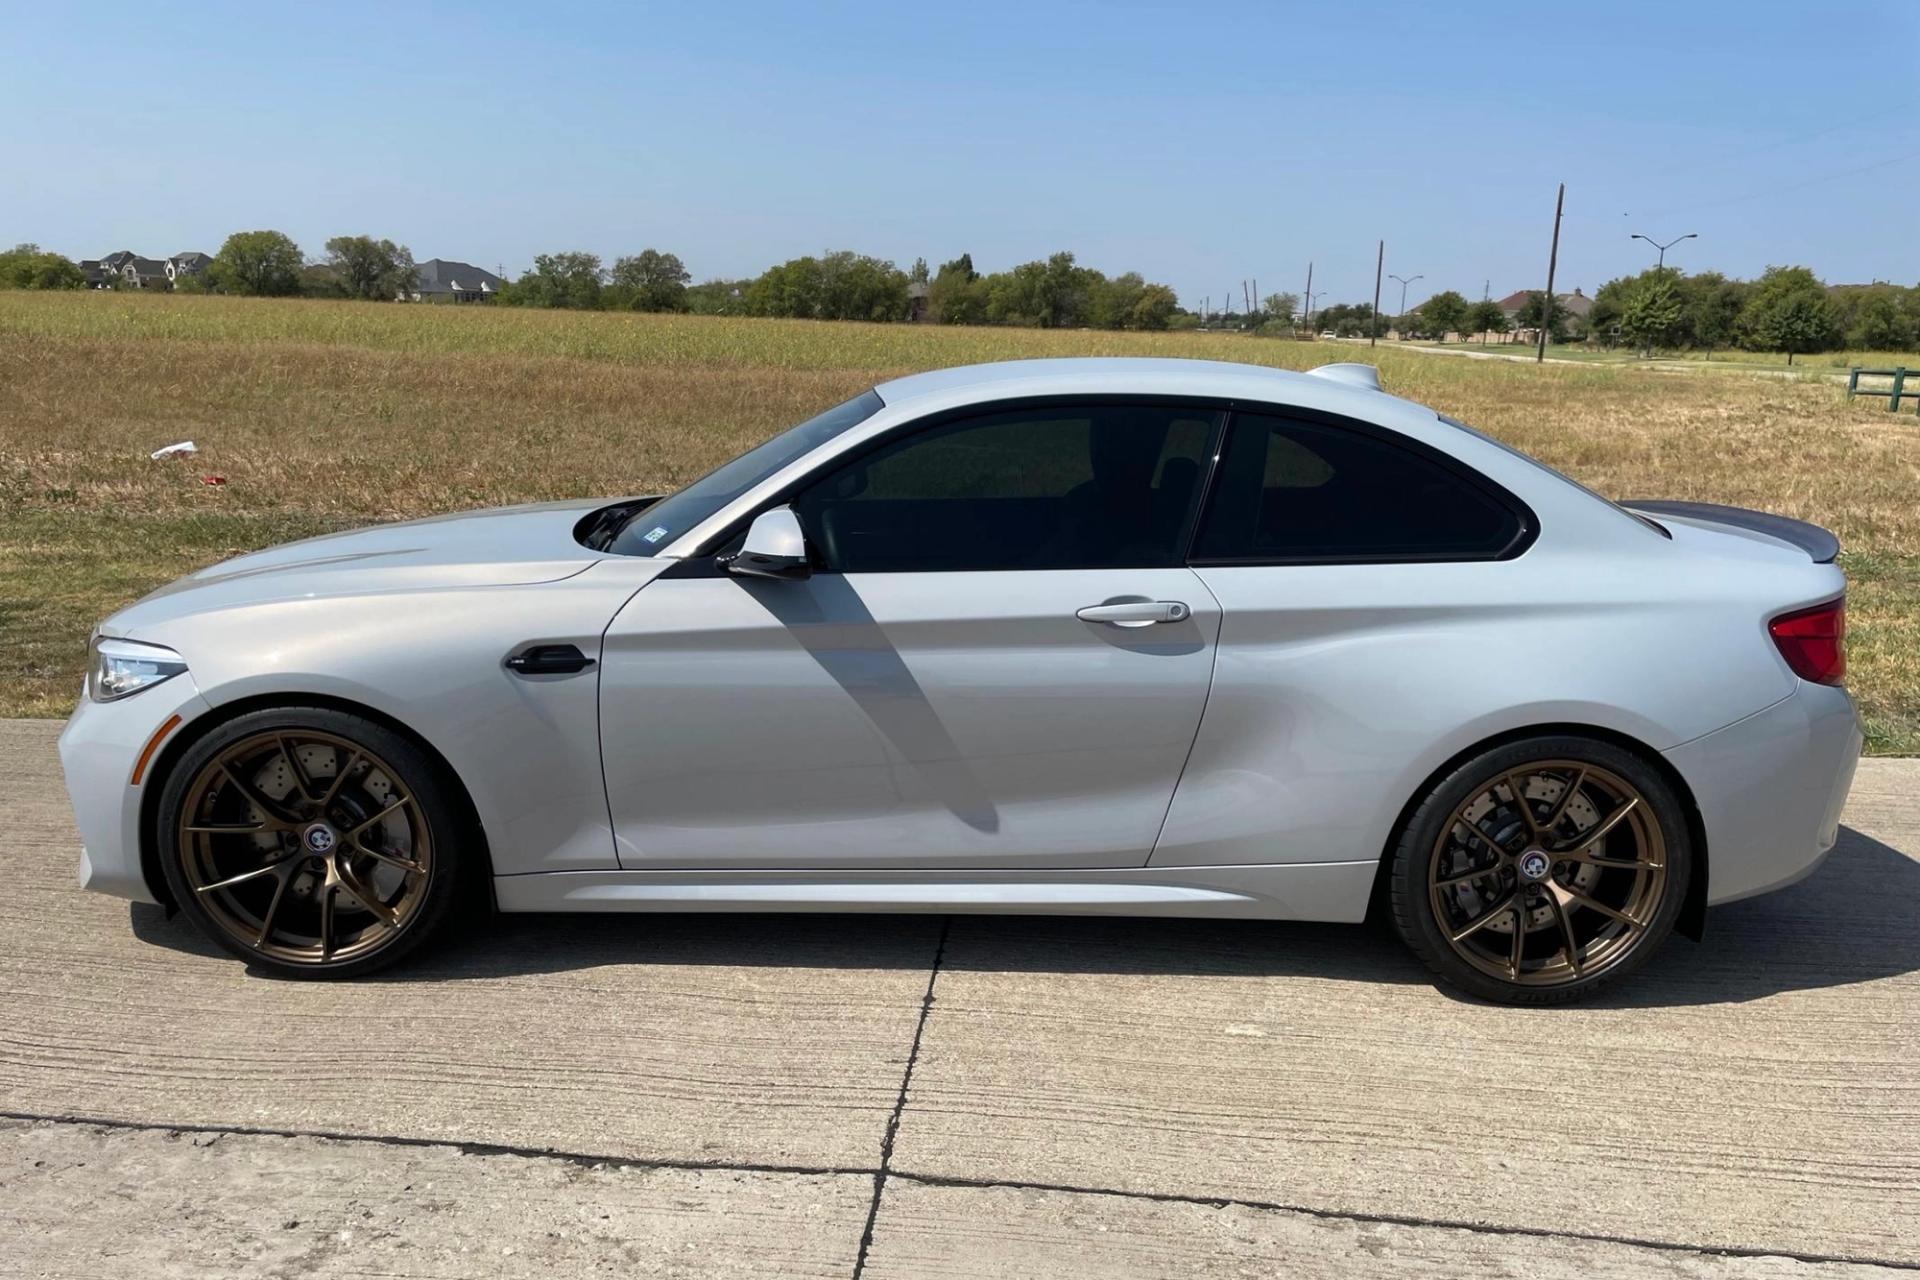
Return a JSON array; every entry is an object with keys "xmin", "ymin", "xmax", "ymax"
[{"xmin": 0, "ymin": 230, "xmax": 1920, "ymax": 363}]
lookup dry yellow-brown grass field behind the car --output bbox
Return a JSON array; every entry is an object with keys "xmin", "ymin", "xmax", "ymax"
[{"xmin": 0, "ymin": 292, "xmax": 1920, "ymax": 752}]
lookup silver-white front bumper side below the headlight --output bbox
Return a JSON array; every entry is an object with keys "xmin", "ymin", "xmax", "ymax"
[{"xmin": 60, "ymin": 674, "xmax": 211, "ymax": 902}]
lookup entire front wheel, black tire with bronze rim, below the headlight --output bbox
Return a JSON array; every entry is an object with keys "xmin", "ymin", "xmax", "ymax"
[{"xmin": 156, "ymin": 708, "xmax": 463, "ymax": 977}]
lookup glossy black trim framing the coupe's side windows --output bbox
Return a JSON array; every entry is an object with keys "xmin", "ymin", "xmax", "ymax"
[{"xmin": 660, "ymin": 393, "xmax": 1540, "ymax": 578}]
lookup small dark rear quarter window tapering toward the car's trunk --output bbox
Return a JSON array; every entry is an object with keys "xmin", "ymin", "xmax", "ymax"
[{"xmin": 1194, "ymin": 415, "xmax": 1523, "ymax": 560}]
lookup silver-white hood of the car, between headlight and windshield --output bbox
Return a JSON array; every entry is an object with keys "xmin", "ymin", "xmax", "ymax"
[{"xmin": 100, "ymin": 501, "xmax": 605, "ymax": 635}]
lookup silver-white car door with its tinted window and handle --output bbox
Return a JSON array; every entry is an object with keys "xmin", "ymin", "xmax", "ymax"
[{"xmin": 601, "ymin": 403, "xmax": 1221, "ymax": 869}]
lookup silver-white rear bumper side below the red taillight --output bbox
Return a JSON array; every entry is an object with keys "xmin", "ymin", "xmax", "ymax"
[{"xmin": 1663, "ymin": 681, "xmax": 1864, "ymax": 906}]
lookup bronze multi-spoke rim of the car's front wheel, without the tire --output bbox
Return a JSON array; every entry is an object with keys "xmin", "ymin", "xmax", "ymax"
[{"xmin": 175, "ymin": 727, "xmax": 436, "ymax": 967}]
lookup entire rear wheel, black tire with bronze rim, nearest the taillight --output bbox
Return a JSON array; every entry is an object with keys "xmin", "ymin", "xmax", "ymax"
[{"xmin": 1388, "ymin": 735, "xmax": 1693, "ymax": 1006}]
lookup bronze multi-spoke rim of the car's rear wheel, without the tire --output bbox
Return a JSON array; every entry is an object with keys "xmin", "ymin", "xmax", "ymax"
[{"xmin": 1427, "ymin": 760, "xmax": 1672, "ymax": 986}]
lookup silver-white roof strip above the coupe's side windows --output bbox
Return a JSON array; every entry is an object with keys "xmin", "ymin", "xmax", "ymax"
[{"xmin": 874, "ymin": 355, "xmax": 1432, "ymax": 418}]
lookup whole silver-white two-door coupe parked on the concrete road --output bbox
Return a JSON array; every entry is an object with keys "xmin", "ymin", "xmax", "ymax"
[{"xmin": 61, "ymin": 359, "xmax": 1862, "ymax": 1004}]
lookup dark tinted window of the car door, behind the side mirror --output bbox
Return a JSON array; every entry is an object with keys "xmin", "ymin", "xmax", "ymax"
[{"xmin": 793, "ymin": 405, "xmax": 1219, "ymax": 574}]
